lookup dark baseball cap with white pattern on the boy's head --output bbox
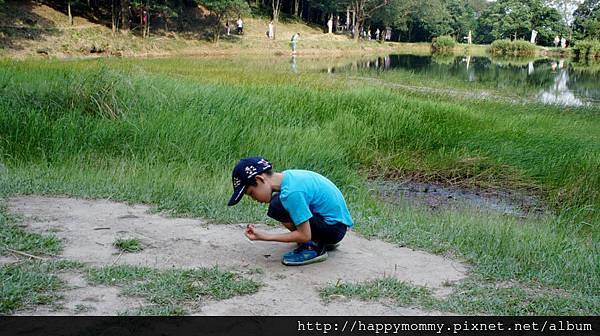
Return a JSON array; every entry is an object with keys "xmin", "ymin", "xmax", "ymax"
[{"xmin": 227, "ymin": 156, "xmax": 273, "ymax": 206}]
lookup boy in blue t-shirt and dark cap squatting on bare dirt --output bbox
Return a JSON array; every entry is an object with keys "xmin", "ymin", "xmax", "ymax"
[{"xmin": 227, "ymin": 157, "xmax": 353, "ymax": 266}]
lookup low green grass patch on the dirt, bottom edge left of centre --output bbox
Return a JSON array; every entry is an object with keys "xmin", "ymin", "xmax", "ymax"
[{"xmin": 87, "ymin": 265, "xmax": 260, "ymax": 315}]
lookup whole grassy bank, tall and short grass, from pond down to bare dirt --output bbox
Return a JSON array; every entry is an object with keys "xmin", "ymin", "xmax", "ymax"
[{"xmin": 0, "ymin": 59, "xmax": 600, "ymax": 314}]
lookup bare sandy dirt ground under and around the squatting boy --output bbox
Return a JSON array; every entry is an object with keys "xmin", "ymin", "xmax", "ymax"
[{"xmin": 4, "ymin": 196, "xmax": 467, "ymax": 315}]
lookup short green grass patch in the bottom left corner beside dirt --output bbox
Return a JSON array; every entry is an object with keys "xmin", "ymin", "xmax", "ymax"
[{"xmin": 0, "ymin": 260, "xmax": 83, "ymax": 314}]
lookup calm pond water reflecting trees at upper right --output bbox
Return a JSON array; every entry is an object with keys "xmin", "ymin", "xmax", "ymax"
[{"xmin": 314, "ymin": 55, "xmax": 600, "ymax": 106}]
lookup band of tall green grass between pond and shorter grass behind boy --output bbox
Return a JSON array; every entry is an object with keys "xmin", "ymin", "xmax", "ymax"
[{"xmin": 0, "ymin": 60, "xmax": 600, "ymax": 220}]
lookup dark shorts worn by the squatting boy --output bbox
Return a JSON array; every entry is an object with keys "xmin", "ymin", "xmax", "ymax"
[{"xmin": 267, "ymin": 193, "xmax": 348, "ymax": 246}]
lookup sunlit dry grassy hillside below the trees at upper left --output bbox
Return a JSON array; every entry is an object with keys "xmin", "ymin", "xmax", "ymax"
[{"xmin": 0, "ymin": 1, "xmax": 412, "ymax": 58}]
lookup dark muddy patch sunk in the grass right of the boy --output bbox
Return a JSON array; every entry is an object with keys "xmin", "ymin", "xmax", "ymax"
[{"xmin": 370, "ymin": 180, "xmax": 546, "ymax": 217}]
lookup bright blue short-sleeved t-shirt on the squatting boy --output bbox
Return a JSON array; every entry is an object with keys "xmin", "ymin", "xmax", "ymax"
[{"xmin": 279, "ymin": 170, "xmax": 354, "ymax": 227}]
